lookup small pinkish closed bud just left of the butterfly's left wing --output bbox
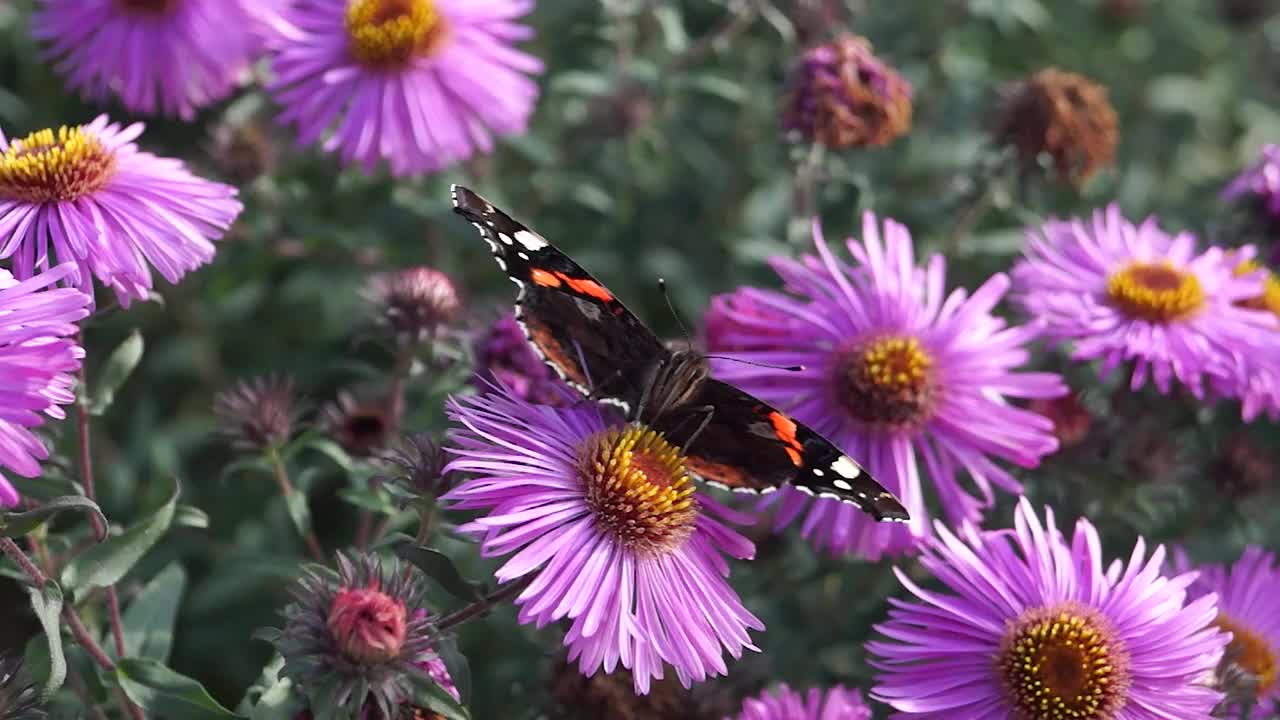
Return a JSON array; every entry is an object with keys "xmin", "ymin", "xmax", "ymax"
[{"xmin": 365, "ymin": 266, "xmax": 461, "ymax": 342}]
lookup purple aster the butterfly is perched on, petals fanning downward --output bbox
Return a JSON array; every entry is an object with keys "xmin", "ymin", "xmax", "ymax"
[{"xmin": 443, "ymin": 384, "xmax": 764, "ymax": 694}]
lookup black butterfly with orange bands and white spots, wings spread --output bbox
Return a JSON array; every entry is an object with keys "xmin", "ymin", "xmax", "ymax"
[{"xmin": 452, "ymin": 184, "xmax": 909, "ymax": 521}]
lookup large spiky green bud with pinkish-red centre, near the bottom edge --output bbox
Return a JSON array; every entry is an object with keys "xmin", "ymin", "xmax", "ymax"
[{"xmin": 261, "ymin": 553, "xmax": 457, "ymax": 719}]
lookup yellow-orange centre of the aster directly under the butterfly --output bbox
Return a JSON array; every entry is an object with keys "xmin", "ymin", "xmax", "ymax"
[{"xmin": 577, "ymin": 425, "xmax": 698, "ymax": 552}]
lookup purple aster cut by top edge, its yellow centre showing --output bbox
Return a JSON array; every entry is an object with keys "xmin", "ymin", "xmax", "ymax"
[{"xmin": 271, "ymin": 0, "xmax": 543, "ymax": 176}]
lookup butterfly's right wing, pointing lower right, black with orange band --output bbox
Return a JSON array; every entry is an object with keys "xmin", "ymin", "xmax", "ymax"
[{"xmin": 644, "ymin": 379, "xmax": 910, "ymax": 521}]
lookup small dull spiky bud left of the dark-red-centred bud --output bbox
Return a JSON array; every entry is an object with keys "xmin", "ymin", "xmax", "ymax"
[{"xmin": 214, "ymin": 375, "xmax": 301, "ymax": 450}]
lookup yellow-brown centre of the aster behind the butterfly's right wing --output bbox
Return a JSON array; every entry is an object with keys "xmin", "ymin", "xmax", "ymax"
[{"xmin": 836, "ymin": 336, "xmax": 934, "ymax": 429}]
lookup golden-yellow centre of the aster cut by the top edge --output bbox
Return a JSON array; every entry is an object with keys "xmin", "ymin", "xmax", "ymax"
[{"xmin": 347, "ymin": 0, "xmax": 447, "ymax": 69}]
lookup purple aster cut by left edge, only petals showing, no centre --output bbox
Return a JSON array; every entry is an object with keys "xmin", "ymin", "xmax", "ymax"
[{"xmin": 0, "ymin": 264, "xmax": 90, "ymax": 507}]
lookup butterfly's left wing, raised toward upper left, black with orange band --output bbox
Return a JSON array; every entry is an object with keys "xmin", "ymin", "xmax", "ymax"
[{"xmin": 453, "ymin": 184, "xmax": 668, "ymax": 413}]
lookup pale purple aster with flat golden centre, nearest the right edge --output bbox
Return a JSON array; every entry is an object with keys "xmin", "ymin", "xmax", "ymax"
[{"xmin": 1012, "ymin": 205, "xmax": 1280, "ymax": 397}]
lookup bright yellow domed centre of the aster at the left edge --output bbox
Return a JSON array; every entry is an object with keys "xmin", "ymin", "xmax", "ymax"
[{"xmin": 0, "ymin": 126, "xmax": 115, "ymax": 202}]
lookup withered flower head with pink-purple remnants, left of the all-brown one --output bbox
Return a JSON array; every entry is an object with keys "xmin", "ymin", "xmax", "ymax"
[{"xmin": 782, "ymin": 35, "xmax": 911, "ymax": 150}]
